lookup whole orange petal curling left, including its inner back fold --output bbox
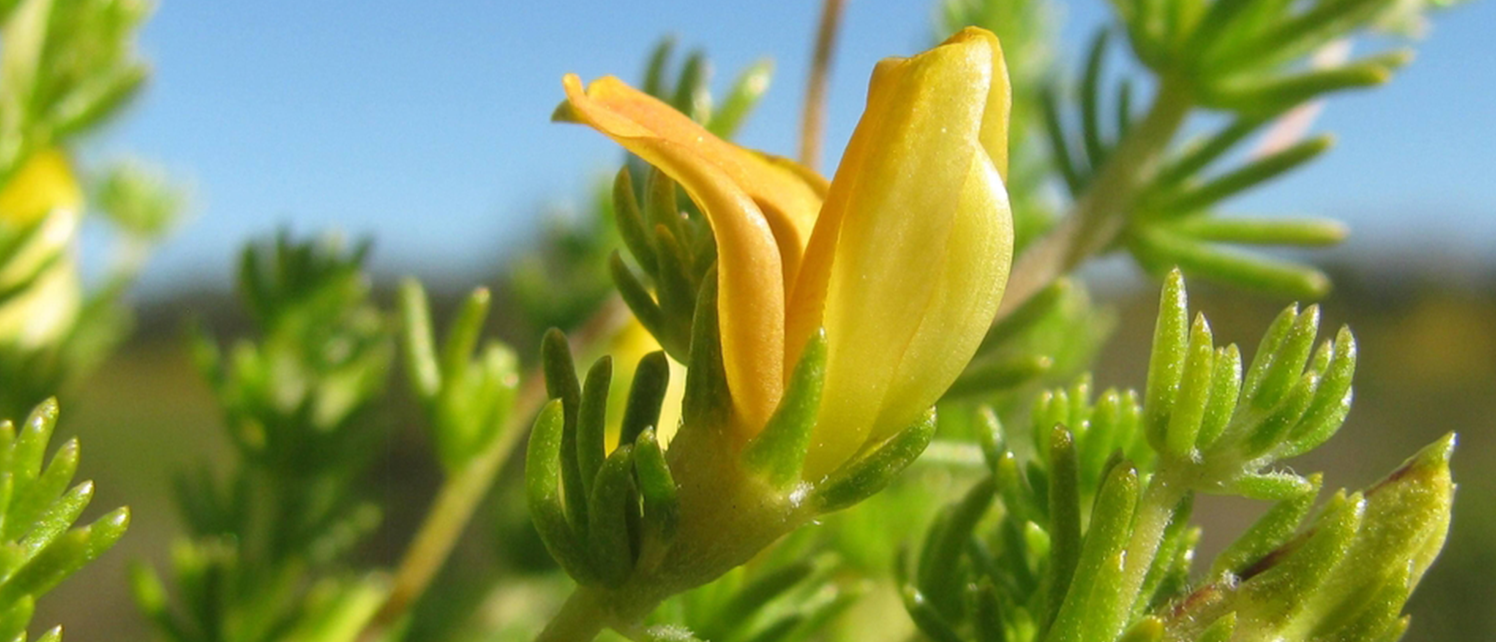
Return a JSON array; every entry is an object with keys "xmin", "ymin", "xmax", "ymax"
[{"xmin": 564, "ymin": 75, "xmax": 820, "ymax": 440}]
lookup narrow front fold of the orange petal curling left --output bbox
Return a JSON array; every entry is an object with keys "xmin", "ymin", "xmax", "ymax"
[{"xmin": 564, "ymin": 75, "xmax": 803, "ymax": 440}]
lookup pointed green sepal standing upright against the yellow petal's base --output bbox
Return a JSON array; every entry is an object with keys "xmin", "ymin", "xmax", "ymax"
[{"xmin": 742, "ymin": 329, "xmax": 826, "ymax": 489}]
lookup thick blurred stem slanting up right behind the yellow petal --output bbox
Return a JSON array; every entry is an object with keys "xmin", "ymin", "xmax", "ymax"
[{"xmin": 996, "ymin": 78, "xmax": 1194, "ymax": 320}]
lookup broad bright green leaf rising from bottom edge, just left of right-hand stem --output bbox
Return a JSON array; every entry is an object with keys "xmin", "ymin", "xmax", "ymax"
[{"xmin": 1044, "ymin": 464, "xmax": 1140, "ymax": 642}]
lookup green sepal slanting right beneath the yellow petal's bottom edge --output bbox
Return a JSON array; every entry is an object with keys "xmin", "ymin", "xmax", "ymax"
[{"xmin": 811, "ymin": 409, "xmax": 935, "ymax": 513}]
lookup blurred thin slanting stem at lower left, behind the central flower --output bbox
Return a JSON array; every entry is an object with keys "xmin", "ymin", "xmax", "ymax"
[{"xmin": 359, "ymin": 295, "xmax": 628, "ymax": 642}]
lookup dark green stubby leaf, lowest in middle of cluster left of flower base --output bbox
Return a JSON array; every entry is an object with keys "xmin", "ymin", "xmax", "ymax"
[{"xmin": 588, "ymin": 444, "xmax": 639, "ymax": 587}]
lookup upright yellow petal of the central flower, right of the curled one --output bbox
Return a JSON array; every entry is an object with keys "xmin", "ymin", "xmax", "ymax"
[{"xmin": 787, "ymin": 30, "xmax": 1013, "ymax": 479}]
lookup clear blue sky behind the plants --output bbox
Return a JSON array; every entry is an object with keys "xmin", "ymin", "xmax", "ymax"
[{"xmin": 88, "ymin": 0, "xmax": 1496, "ymax": 292}]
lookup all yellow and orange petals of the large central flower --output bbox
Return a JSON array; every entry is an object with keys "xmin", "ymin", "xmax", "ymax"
[{"xmin": 564, "ymin": 28, "xmax": 1013, "ymax": 479}]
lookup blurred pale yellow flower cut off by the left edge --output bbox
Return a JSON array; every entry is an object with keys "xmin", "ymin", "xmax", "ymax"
[{"xmin": 0, "ymin": 150, "xmax": 84, "ymax": 347}]
